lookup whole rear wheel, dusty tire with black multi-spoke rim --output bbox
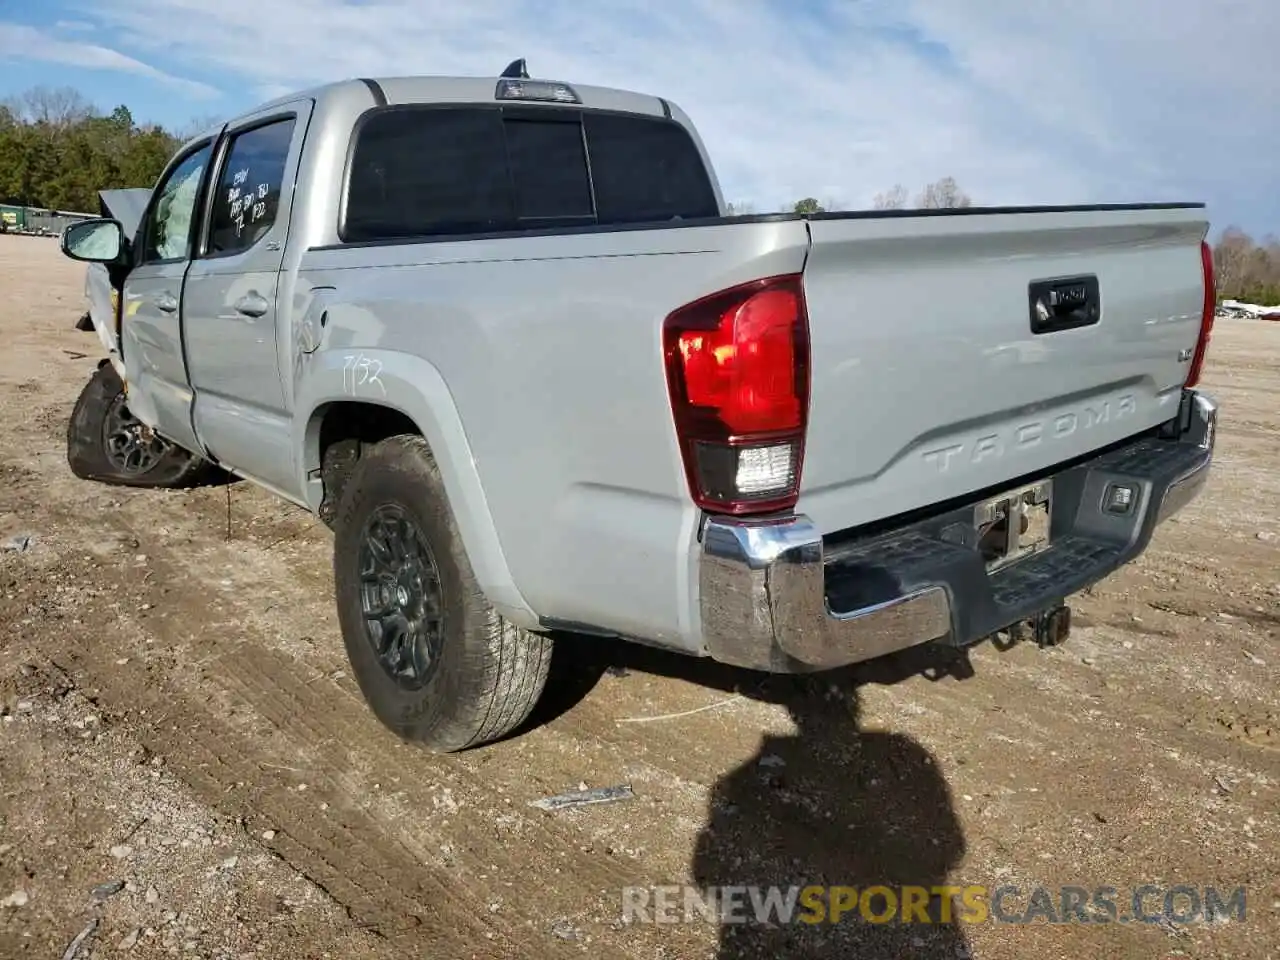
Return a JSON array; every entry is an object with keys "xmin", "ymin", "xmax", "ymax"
[{"xmin": 334, "ymin": 435, "xmax": 552, "ymax": 753}]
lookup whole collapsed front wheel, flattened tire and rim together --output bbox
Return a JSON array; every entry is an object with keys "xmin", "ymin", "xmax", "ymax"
[{"xmin": 67, "ymin": 364, "xmax": 212, "ymax": 488}]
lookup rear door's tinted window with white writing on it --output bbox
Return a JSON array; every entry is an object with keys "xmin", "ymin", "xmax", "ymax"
[{"xmin": 209, "ymin": 116, "xmax": 294, "ymax": 253}]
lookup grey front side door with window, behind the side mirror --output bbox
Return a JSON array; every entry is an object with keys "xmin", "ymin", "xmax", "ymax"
[{"xmin": 120, "ymin": 141, "xmax": 212, "ymax": 453}]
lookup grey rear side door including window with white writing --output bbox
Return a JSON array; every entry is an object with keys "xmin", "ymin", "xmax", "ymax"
[{"xmin": 183, "ymin": 100, "xmax": 311, "ymax": 495}]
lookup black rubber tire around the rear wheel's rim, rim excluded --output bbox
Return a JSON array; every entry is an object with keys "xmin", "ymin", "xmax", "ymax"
[{"xmin": 334, "ymin": 435, "xmax": 552, "ymax": 753}]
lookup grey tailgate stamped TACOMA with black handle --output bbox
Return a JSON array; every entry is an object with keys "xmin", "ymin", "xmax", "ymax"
[{"xmin": 797, "ymin": 206, "xmax": 1208, "ymax": 532}]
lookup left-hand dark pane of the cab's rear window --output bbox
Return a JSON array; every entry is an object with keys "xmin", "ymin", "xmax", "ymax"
[{"xmin": 344, "ymin": 109, "xmax": 513, "ymax": 241}]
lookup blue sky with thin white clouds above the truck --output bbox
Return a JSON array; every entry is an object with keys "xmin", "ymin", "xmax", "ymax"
[{"xmin": 0, "ymin": 0, "xmax": 1280, "ymax": 237}]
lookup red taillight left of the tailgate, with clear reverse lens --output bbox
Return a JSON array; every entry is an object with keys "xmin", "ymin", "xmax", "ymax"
[{"xmin": 663, "ymin": 274, "xmax": 809, "ymax": 515}]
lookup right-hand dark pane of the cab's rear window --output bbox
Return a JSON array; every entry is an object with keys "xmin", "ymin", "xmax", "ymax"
[{"xmin": 584, "ymin": 113, "xmax": 719, "ymax": 224}]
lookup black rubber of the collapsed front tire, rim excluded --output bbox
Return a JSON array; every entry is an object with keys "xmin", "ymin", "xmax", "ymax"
[{"xmin": 67, "ymin": 364, "xmax": 214, "ymax": 488}]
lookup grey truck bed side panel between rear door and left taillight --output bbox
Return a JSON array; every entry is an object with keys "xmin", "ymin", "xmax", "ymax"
[{"xmin": 294, "ymin": 220, "xmax": 808, "ymax": 646}]
